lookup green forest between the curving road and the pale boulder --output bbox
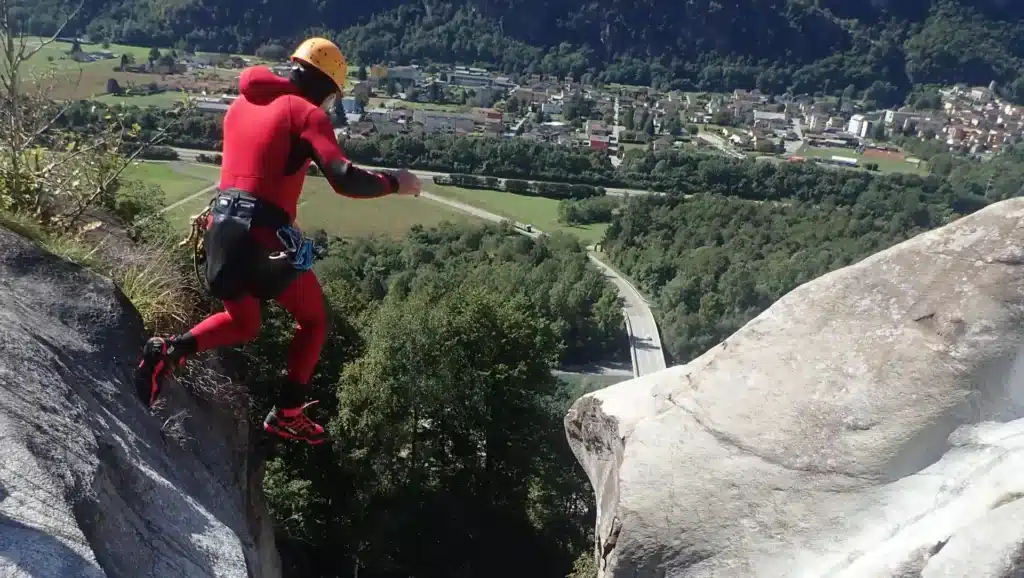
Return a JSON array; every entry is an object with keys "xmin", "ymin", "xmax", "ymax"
[{"xmin": 604, "ymin": 147, "xmax": 1024, "ymax": 363}]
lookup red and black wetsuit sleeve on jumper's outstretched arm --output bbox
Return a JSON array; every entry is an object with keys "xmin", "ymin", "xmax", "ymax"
[{"xmin": 299, "ymin": 108, "xmax": 398, "ymax": 199}]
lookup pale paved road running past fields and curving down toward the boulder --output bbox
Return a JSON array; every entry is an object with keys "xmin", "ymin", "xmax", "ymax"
[{"xmin": 421, "ymin": 192, "xmax": 666, "ymax": 377}]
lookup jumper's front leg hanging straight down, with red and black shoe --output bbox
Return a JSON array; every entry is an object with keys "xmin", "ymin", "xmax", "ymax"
[{"xmin": 263, "ymin": 271, "xmax": 327, "ymax": 444}]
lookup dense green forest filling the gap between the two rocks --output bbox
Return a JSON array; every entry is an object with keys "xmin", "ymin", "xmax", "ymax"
[{"xmin": 230, "ymin": 224, "xmax": 606, "ymax": 578}]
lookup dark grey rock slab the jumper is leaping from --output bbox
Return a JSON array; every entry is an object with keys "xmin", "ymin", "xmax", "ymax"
[{"xmin": 0, "ymin": 229, "xmax": 281, "ymax": 578}]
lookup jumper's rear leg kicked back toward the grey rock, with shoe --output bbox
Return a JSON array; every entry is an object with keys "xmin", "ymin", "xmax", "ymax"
[{"xmin": 135, "ymin": 297, "xmax": 260, "ymax": 407}]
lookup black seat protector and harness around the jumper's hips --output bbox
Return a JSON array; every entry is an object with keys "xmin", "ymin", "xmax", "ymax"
[{"xmin": 203, "ymin": 191, "xmax": 299, "ymax": 300}]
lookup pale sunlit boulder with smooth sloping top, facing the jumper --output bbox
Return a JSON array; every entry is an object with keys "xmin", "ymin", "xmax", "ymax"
[{"xmin": 565, "ymin": 199, "xmax": 1024, "ymax": 578}]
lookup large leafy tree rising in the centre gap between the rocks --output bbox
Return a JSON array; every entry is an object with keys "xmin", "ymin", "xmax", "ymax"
[{"xmin": 332, "ymin": 285, "xmax": 574, "ymax": 576}]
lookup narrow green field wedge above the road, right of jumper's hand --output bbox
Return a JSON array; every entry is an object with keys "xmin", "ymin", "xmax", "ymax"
[{"xmin": 425, "ymin": 182, "xmax": 608, "ymax": 245}]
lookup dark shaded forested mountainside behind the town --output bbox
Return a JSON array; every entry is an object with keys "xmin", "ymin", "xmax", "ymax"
[{"xmin": 14, "ymin": 0, "xmax": 1024, "ymax": 100}]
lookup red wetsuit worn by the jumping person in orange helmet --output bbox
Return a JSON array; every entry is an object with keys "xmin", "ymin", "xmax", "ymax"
[{"xmin": 189, "ymin": 67, "xmax": 397, "ymax": 384}]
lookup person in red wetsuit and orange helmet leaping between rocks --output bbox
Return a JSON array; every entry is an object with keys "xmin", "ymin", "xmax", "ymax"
[{"xmin": 136, "ymin": 38, "xmax": 420, "ymax": 444}]
